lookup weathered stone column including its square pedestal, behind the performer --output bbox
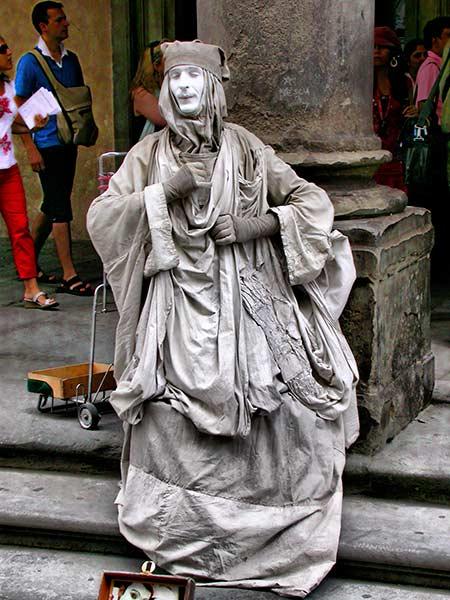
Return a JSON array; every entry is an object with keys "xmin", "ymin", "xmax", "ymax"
[{"xmin": 197, "ymin": 0, "xmax": 433, "ymax": 452}]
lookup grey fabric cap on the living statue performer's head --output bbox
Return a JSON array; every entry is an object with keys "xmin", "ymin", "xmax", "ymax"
[{"xmin": 161, "ymin": 40, "xmax": 230, "ymax": 81}]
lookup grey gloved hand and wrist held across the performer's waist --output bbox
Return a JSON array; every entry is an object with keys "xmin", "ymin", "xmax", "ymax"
[{"xmin": 211, "ymin": 213, "xmax": 280, "ymax": 246}]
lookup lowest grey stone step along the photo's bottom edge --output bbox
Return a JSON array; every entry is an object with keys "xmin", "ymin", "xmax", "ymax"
[{"xmin": 0, "ymin": 546, "xmax": 449, "ymax": 600}]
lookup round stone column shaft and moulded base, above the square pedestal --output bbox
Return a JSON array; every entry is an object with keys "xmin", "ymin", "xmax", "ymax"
[{"xmin": 197, "ymin": 0, "xmax": 406, "ymax": 216}]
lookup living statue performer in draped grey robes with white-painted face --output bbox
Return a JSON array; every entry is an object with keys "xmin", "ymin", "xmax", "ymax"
[{"xmin": 88, "ymin": 41, "xmax": 358, "ymax": 598}]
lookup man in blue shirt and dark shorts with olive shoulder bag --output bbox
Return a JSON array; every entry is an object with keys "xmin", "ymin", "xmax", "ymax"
[{"xmin": 16, "ymin": 1, "xmax": 98, "ymax": 296}]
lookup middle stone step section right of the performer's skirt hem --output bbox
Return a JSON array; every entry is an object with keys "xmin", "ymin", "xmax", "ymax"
[{"xmin": 338, "ymin": 496, "xmax": 450, "ymax": 589}]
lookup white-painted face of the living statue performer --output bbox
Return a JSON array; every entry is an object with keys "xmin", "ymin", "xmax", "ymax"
[{"xmin": 168, "ymin": 65, "xmax": 205, "ymax": 115}]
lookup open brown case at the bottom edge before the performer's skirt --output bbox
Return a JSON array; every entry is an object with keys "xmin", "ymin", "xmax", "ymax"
[{"xmin": 98, "ymin": 571, "xmax": 195, "ymax": 600}]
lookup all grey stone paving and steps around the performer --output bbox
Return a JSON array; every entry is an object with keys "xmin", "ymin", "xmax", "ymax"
[{"xmin": 0, "ymin": 241, "xmax": 450, "ymax": 600}]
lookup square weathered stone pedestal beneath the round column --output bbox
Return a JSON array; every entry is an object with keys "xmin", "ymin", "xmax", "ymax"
[{"xmin": 335, "ymin": 207, "xmax": 434, "ymax": 454}]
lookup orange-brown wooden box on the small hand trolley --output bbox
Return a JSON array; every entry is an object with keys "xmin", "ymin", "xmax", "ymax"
[{"xmin": 28, "ymin": 363, "xmax": 116, "ymax": 399}]
